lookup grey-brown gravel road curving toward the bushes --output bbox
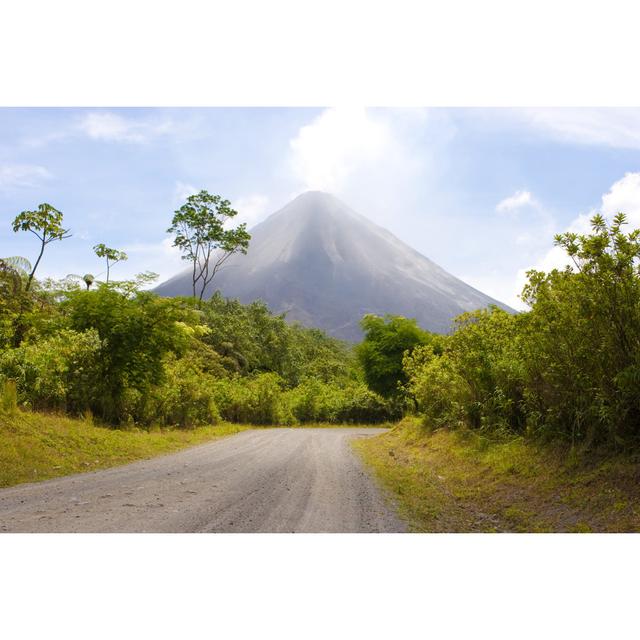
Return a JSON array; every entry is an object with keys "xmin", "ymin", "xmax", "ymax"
[{"xmin": 0, "ymin": 428, "xmax": 405, "ymax": 533}]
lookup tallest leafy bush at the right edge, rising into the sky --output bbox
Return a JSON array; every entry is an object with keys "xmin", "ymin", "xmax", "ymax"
[{"xmin": 521, "ymin": 213, "xmax": 640, "ymax": 446}]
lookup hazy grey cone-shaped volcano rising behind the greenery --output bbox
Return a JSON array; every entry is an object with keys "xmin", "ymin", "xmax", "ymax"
[{"xmin": 156, "ymin": 191, "xmax": 510, "ymax": 340}]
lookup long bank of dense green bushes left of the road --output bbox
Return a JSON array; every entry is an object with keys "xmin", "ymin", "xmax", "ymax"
[{"xmin": 0, "ymin": 276, "xmax": 384, "ymax": 427}]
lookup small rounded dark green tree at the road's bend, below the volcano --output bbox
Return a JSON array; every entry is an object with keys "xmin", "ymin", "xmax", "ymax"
[{"xmin": 356, "ymin": 314, "xmax": 434, "ymax": 398}]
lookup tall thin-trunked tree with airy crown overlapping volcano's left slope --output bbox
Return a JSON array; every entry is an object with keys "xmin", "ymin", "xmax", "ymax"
[{"xmin": 167, "ymin": 191, "xmax": 251, "ymax": 302}]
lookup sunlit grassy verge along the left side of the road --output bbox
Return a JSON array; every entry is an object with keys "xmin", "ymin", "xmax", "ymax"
[{"xmin": 0, "ymin": 410, "xmax": 250, "ymax": 487}]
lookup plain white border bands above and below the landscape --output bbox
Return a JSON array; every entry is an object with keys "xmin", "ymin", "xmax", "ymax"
[{"xmin": 0, "ymin": 0, "xmax": 640, "ymax": 640}]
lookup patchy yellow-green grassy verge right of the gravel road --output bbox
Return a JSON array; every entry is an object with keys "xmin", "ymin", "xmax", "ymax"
[{"xmin": 354, "ymin": 420, "xmax": 640, "ymax": 532}]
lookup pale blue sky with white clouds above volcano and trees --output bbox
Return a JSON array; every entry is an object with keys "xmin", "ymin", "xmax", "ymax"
[{"xmin": 0, "ymin": 108, "xmax": 640, "ymax": 306}]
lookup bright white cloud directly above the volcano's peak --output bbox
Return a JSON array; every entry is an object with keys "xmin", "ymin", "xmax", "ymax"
[{"xmin": 282, "ymin": 107, "xmax": 440, "ymax": 233}]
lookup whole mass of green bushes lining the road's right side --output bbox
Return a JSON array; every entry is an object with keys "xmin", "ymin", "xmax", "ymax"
[{"xmin": 405, "ymin": 214, "xmax": 640, "ymax": 447}]
